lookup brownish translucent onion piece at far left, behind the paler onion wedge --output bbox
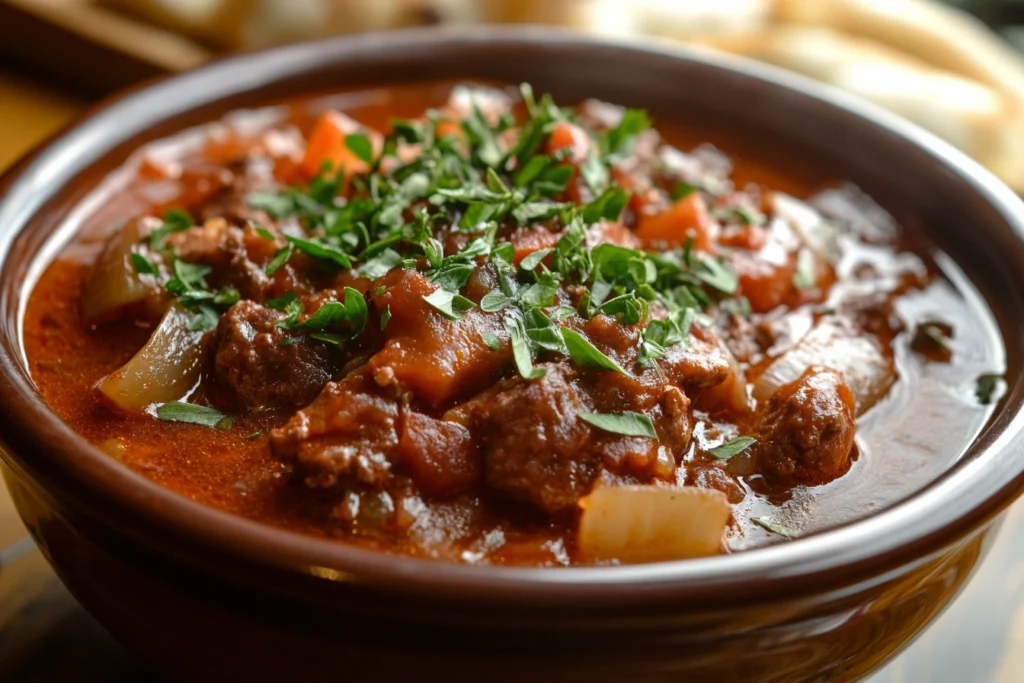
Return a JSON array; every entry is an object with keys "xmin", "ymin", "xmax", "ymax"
[{"xmin": 81, "ymin": 217, "xmax": 165, "ymax": 323}]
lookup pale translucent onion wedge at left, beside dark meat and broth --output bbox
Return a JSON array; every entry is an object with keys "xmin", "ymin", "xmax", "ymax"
[{"xmin": 97, "ymin": 304, "xmax": 203, "ymax": 413}]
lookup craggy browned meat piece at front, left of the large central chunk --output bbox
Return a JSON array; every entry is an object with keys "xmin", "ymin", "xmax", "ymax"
[{"xmin": 270, "ymin": 375, "xmax": 404, "ymax": 488}]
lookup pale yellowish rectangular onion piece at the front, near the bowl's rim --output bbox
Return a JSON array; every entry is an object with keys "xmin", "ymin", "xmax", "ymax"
[{"xmin": 578, "ymin": 486, "xmax": 731, "ymax": 563}]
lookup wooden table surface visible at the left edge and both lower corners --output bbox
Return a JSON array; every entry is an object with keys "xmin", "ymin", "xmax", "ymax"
[{"xmin": 0, "ymin": 67, "xmax": 1024, "ymax": 683}]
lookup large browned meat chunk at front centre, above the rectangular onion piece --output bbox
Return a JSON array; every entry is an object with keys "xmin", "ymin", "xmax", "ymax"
[{"xmin": 458, "ymin": 364, "xmax": 598, "ymax": 513}]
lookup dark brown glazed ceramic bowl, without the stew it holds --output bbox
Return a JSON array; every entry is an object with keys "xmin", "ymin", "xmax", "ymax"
[{"xmin": 0, "ymin": 29, "xmax": 1024, "ymax": 683}]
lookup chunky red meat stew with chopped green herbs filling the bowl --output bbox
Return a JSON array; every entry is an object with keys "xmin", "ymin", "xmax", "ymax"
[{"xmin": 25, "ymin": 84, "xmax": 1002, "ymax": 566}]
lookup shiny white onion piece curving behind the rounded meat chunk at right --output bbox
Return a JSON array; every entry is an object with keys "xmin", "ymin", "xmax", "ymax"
[{"xmin": 754, "ymin": 322, "xmax": 896, "ymax": 415}]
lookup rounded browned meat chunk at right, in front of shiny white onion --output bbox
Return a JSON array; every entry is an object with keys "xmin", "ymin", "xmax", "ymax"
[{"xmin": 752, "ymin": 366, "xmax": 856, "ymax": 486}]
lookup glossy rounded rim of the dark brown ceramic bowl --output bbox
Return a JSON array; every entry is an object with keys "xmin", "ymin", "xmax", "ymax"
[{"xmin": 0, "ymin": 27, "xmax": 1024, "ymax": 606}]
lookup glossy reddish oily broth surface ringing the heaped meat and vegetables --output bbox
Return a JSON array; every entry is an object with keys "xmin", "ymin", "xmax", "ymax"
[{"xmin": 25, "ymin": 83, "xmax": 1004, "ymax": 565}]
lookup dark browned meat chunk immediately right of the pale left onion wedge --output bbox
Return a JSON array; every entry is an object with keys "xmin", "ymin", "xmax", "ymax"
[{"xmin": 211, "ymin": 301, "xmax": 333, "ymax": 411}]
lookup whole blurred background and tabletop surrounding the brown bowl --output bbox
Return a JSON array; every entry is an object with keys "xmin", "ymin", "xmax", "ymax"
[{"xmin": 0, "ymin": 0, "xmax": 1024, "ymax": 683}]
